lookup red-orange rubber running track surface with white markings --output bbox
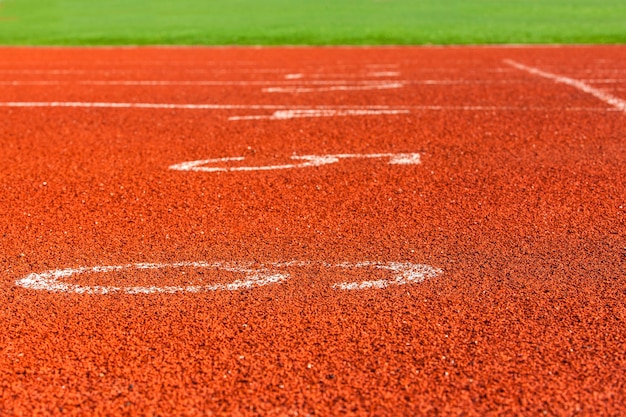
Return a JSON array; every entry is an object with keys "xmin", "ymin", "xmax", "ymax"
[{"xmin": 0, "ymin": 46, "xmax": 626, "ymax": 415}]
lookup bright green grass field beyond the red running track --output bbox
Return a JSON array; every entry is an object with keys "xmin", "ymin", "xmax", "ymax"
[{"xmin": 0, "ymin": 0, "xmax": 626, "ymax": 45}]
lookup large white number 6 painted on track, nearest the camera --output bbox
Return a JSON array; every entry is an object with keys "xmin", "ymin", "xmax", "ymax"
[{"xmin": 15, "ymin": 261, "xmax": 443, "ymax": 295}]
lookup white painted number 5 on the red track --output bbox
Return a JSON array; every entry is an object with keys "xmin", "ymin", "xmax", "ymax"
[{"xmin": 169, "ymin": 153, "xmax": 421, "ymax": 172}]
